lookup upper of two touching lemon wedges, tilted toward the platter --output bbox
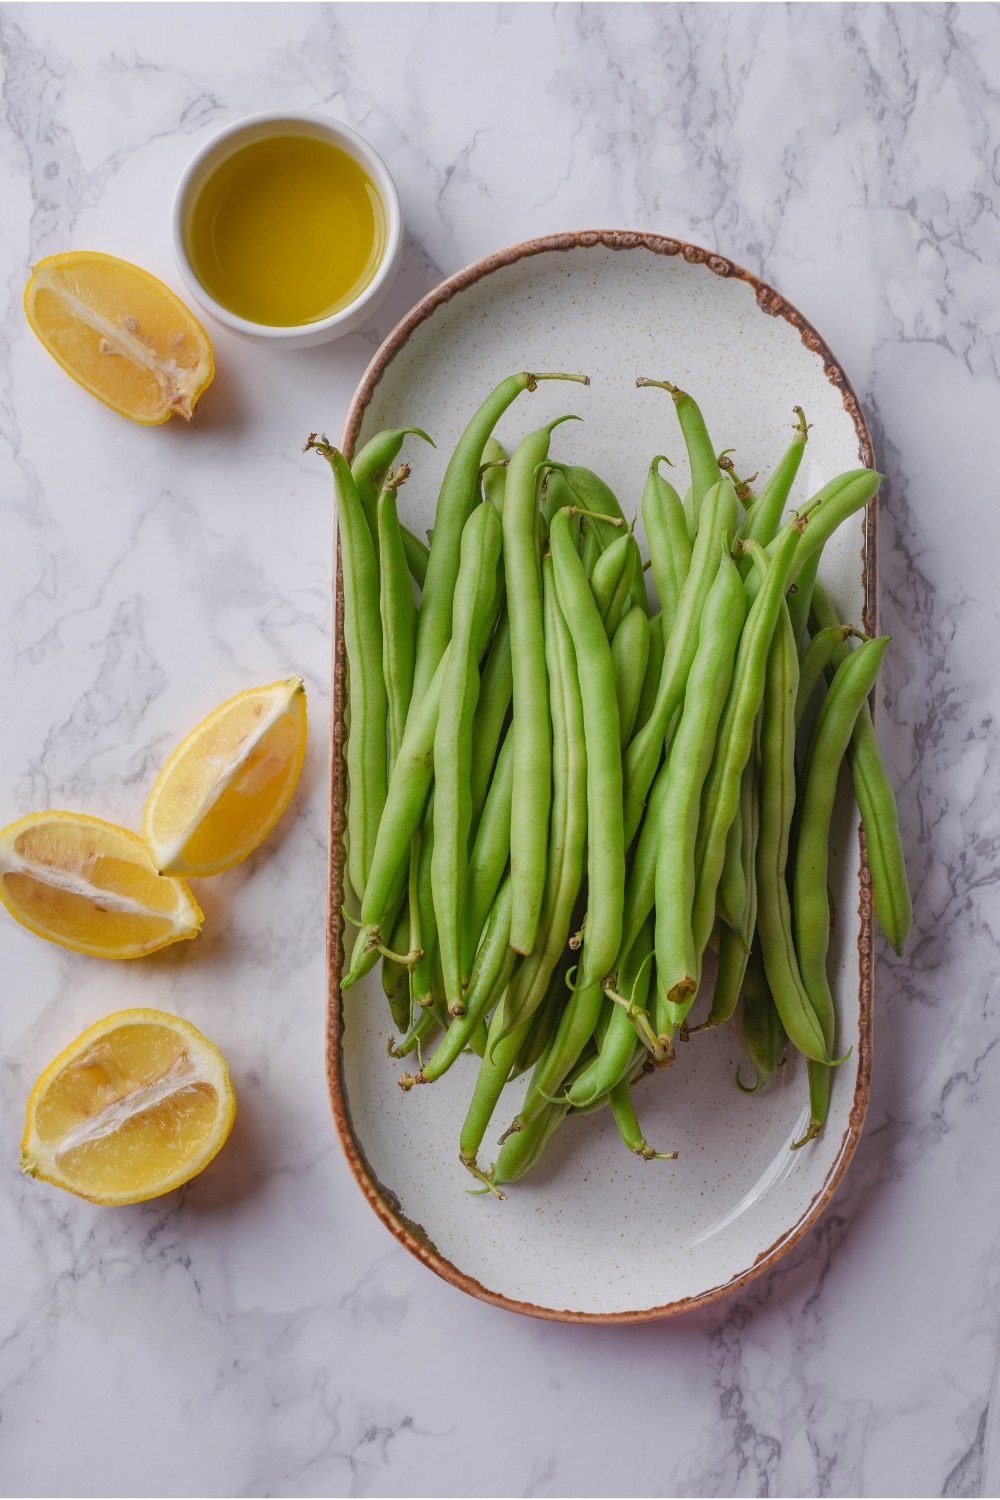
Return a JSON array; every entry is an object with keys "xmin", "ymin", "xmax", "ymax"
[{"xmin": 142, "ymin": 677, "xmax": 307, "ymax": 875}]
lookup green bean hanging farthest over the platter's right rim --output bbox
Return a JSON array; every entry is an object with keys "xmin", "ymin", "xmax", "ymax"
[{"xmin": 813, "ymin": 581, "xmax": 913, "ymax": 954}]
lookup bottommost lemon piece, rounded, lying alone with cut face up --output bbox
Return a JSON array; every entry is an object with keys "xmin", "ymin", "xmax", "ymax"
[{"xmin": 21, "ymin": 1008, "xmax": 235, "ymax": 1205}]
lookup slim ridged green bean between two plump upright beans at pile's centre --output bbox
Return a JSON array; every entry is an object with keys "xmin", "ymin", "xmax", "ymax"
[{"xmin": 505, "ymin": 555, "xmax": 586, "ymax": 1031}]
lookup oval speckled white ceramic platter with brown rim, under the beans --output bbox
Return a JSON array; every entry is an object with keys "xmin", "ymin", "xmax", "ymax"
[{"xmin": 328, "ymin": 233, "xmax": 874, "ymax": 1322}]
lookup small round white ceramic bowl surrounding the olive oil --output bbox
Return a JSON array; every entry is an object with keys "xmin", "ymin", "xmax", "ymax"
[{"xmin": 172, "ymin": 110, "xmax": 403, "ymax": 350}]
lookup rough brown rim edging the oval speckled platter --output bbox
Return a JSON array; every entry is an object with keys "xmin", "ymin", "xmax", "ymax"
[{"xmin": 327, "ymin": 230, "xmax": 877, "ymax": 1323}]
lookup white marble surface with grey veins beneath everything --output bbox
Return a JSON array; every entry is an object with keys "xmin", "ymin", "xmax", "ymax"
[{"xmin": 0, "ymin": 3, "xmax": 1000, "ymax": 1496}]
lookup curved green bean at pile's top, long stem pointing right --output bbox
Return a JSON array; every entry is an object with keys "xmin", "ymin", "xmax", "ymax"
[{"xmin": 412, "ymin": 371, "xmax": 586, "ymax": 704}]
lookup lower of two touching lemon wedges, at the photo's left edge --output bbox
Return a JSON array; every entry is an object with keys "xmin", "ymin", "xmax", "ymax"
[{"xmin": 0, "ymin": 812, "xmax": 202, "ymax": 959}]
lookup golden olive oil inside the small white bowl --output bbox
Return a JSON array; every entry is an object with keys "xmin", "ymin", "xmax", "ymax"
[{"xmin": 187, "ymin": 135, "xmax": 385, "ymax": 327}]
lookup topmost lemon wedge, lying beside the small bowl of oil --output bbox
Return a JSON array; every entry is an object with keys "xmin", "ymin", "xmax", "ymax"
[{"xmin": 24, "ymin": 251, "xmax": 216, "ymax": 426}]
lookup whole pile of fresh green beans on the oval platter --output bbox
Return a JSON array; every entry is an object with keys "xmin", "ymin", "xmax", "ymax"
[{"xmin": 314, "ymin": 372, "xmax": 912, "ymax": 1197}]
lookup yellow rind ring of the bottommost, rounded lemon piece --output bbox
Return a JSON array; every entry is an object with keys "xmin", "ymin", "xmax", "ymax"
[{"xmin": 21, "ymin": 1007, "xmax": 235, "ymax": 1208}]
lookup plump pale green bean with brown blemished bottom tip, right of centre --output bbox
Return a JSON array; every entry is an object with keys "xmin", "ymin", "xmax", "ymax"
[{"xmin": 657, "ymin": 543, "xmax": 743, "ymax": 1005}]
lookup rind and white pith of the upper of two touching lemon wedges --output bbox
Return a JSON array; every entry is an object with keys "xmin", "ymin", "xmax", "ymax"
[{"xmin": 142, "ymin": 677, "xmax": 307, "ymax": 879}]
